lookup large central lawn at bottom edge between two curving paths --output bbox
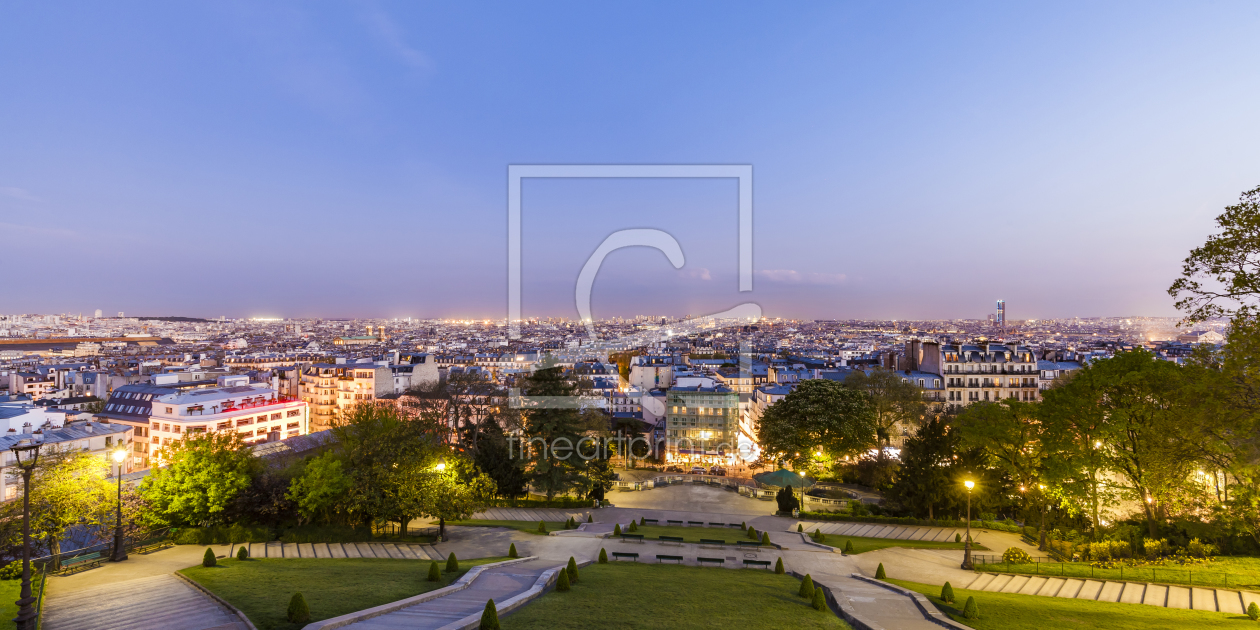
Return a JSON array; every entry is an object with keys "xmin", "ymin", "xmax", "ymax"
[{"xmin": 500, "ymin": 562, "xmax": 849, "ymax": 630}]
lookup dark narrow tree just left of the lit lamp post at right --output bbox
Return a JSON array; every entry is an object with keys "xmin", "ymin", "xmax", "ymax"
[{"xmin": 890, "ymin": 418, "xmax": 958, "ymax": 518}]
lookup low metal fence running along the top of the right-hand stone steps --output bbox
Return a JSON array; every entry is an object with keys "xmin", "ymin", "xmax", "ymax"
[{"xmin": 971, "ymin": 553, "xmax": 1260, "ymax": 588}]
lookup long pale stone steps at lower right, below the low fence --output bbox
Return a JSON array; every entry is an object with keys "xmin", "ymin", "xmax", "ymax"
[{"xmin": 961, "ymin": 573, "xmax": 1260, "ymax": 615}]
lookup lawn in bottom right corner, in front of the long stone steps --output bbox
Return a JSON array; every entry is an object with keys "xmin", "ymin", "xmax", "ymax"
[{"xmin": 888, "ymin": 580, "xmax": 1255, "ymax": 630}]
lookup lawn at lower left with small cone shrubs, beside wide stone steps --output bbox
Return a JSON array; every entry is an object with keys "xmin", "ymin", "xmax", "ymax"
[{"xmin": 180, "ymin": 558, "xmax": 508, "ymax": 630}]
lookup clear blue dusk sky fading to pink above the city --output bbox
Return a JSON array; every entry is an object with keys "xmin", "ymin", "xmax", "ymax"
[{"xmin": 0, "ymin": 0, "xmax": 1260, "ymax": 320}]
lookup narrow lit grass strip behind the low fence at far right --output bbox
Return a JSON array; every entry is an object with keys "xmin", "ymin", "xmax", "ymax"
[{"xmin": 977, "ymin": 557, "xmax": 1260, "ymax": 591}]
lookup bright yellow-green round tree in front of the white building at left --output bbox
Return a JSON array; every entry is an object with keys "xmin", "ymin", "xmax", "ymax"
[{"xmin": 140, "ymin": 432, "xmax": 256, "ymax": 525}]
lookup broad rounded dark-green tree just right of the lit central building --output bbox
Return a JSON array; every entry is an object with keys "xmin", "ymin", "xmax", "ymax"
[{"xmin": 757, "ymin": 379, "xmax": 876, "ymax": 470}]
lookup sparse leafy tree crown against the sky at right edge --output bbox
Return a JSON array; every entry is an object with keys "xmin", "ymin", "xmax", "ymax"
[{"xmin": 1168, "ymin": 182, "xmax": 1260, "ymax": 323}]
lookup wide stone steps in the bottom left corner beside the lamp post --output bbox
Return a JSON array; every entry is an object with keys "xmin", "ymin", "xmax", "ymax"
[{"xmin": 43, "ymin": 575, "xmax": 246, "ymax": 630}]
